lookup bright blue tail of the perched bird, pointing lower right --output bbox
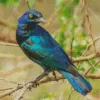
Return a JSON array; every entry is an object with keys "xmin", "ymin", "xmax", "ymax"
[{"xmin": 59, "ymin": 70, "xmax": 92, "ymax": 95}]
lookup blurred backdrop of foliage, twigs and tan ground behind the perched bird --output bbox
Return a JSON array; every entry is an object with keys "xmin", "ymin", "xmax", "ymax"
[{"xmin": 0, "ymin": 0, "xmax": 100, "ymax": 100}]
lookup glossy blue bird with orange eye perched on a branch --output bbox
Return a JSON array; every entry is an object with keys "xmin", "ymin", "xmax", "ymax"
[{"xmin": 16, "ymin": 9, "xmax": 92, "ymax": 96}]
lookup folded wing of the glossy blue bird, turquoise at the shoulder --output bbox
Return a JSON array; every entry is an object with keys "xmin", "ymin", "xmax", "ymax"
[{"xmin": 21, "ymin": 36, "xmax": 74, "ymax": 74}]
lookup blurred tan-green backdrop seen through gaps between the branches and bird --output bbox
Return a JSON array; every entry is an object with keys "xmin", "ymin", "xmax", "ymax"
[{"xmin": 0, "ymin": 0, "xmax": 100, "ymax": 100}]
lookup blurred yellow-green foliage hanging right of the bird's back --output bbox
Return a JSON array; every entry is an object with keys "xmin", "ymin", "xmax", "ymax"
[{"xmin": 55, "ymin": 0, "xmax": 96, "ymax": 72}]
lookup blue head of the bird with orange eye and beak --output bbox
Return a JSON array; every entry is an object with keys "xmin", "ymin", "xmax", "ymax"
[{"xmin": 18, "ymin": 10, "xmax": 45, "ymax": 28}]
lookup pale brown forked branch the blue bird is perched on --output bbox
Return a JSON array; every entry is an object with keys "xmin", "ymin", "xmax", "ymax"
[{"xmin": 0, "ymin": 72, "xmax": 100, "ymax": 100}]
